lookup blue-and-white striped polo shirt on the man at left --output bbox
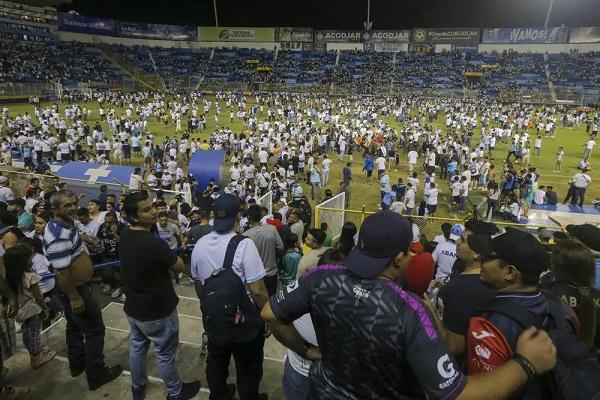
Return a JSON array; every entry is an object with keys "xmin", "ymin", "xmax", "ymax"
[{"xmin": 43, "ymin": 219, "xmax": 85, "ymax": 269}]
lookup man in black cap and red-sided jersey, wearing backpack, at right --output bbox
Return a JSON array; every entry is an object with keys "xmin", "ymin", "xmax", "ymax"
[{"xmin": 467, "ymin": 228, "xmax": 600, "ymax": 399}]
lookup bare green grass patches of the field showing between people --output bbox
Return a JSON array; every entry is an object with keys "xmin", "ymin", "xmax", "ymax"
[{"xmin": 2, "ymin": 97, "xmax": 600, "ymax": 216}]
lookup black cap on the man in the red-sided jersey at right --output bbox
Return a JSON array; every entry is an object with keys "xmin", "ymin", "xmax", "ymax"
[{"xmin": 467, "ymin": 227, "xmax": 550, "ymax": 279}]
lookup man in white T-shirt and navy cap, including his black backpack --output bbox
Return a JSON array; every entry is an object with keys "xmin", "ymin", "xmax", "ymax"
[{"xmin": 191, "ymin": 194, "xmax": 268, "ymax": 400}]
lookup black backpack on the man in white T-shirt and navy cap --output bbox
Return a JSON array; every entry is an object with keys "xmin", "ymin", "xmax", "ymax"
[{"xmin": 200, "ymin": 235, "xmax": 264, "ymax": 346}]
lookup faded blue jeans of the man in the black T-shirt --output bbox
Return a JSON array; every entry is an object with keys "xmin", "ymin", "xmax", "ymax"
[{"xmin": 127, "ymin": 310, "xmax": 181, "ymax": 396}]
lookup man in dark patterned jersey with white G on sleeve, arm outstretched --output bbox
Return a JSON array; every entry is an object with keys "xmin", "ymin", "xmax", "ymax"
[{"xmin": 262, "ymin": 211, "xmax": 556, "ymax": 400}]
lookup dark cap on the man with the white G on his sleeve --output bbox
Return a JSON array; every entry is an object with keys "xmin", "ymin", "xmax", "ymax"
[{"xmin": 346, "ymin": 210, "xmax": 412, "ymax": 278}]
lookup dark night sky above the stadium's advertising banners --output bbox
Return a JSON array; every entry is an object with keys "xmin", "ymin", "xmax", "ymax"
[{"xmin": 61, "ymin": 0, "xmax": 600, "ymax": 29}]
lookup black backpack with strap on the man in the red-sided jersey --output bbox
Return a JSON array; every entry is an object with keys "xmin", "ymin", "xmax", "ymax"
[{"xmin": 481, "ymin": 290, "xmax": 600, "ymax": 400}]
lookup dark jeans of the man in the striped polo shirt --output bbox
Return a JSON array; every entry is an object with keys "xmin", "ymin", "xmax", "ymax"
[{"xmin": 57, "ymin": 283, "xmax": 105, "ymax": 382}]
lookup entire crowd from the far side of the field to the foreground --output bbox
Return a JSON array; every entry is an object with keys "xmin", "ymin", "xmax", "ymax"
[{"xmin": 0, "ymin": 92, "xmax": 600, "ymax": 400}]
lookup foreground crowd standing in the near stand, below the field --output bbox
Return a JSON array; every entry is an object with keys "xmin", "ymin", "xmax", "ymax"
[{"xmin": 0, "ymin": 176, "xmax": 600, "ymax": 400}]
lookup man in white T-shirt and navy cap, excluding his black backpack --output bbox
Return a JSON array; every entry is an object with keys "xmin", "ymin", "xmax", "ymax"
[{"xmin": 191, "ymin": 194, "xmax": 268, "ymax": 400}]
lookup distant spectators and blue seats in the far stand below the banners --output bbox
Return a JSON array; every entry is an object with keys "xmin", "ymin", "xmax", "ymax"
[{"xmin": 0, "ymin": 41, "xmax": 600, "ymax": 96}]
